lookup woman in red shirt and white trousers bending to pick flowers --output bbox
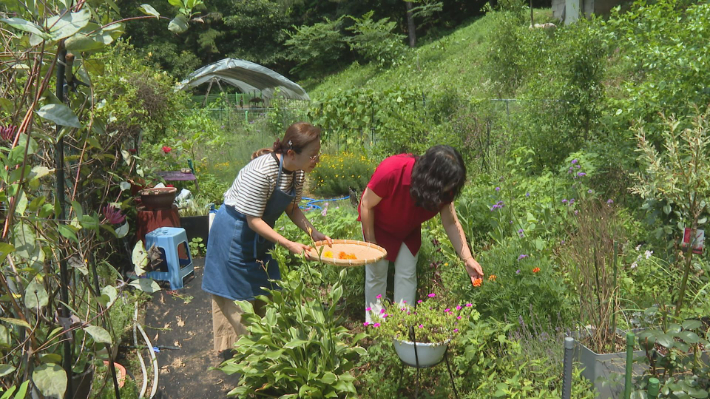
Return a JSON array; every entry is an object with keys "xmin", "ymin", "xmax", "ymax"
[{"xmin": 358, "ymin": 145, "xmax": 483, "ymax": 321}]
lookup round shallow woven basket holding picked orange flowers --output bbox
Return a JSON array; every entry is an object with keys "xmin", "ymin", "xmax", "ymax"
[{"xmin": 309, "ymin": 240, "xmax": 387, "ymax": 266}]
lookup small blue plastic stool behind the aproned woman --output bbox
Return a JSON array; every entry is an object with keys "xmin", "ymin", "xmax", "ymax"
[{"xmin": 145, "ymin": 227, "xmax": 194, "ymax": 290}]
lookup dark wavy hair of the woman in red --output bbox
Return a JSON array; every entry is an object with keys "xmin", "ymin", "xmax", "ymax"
[{"xmin": 409, "ymin": 145, "xmax": 466, "ymax": 212}]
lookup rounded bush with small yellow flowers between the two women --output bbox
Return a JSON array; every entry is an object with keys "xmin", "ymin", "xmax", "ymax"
[{"xmin": 309, "ymin": 152, "xmax": 375, "ymax": 200}]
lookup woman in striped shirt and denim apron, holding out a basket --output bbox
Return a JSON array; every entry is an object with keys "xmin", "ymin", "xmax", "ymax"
[{"xmin": 202, "ymin": 122, "xmax": 332, "ymax": 354}]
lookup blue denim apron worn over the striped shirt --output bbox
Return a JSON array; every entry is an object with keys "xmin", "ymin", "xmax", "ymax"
[{"xmin": 202, "ymin": 155, "xmax": 296, "ymax": 301}]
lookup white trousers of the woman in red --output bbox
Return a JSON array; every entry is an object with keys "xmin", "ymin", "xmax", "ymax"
[{"xmin": 365, "ymin": 243, "xmax": 419, "ymax": 323}]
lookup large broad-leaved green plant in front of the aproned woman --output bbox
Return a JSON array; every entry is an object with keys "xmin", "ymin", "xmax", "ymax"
[{"xmin": 220, "ymin": 255, "xmax": 366, "ymax": 397}]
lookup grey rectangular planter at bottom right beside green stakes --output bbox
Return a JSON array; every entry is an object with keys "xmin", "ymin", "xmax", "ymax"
[{"xmin": 575, "ymin": 337, "xmax": 649, "ymax": 399}]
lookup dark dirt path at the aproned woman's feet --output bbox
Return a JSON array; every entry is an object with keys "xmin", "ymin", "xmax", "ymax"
[{"xmin": 144, "ymin": 258, "xmax": 238, "ymax": 399}]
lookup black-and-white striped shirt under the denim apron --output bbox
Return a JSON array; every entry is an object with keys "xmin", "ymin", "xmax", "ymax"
[{"xmin": 224, "ymin": 153, "xmax": 306, "ymax": 217}]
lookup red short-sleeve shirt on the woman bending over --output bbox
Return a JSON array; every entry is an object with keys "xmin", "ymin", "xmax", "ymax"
[{"xmin": 358, "ymin": 154, "xmax": 439, "ymax": 262}]
